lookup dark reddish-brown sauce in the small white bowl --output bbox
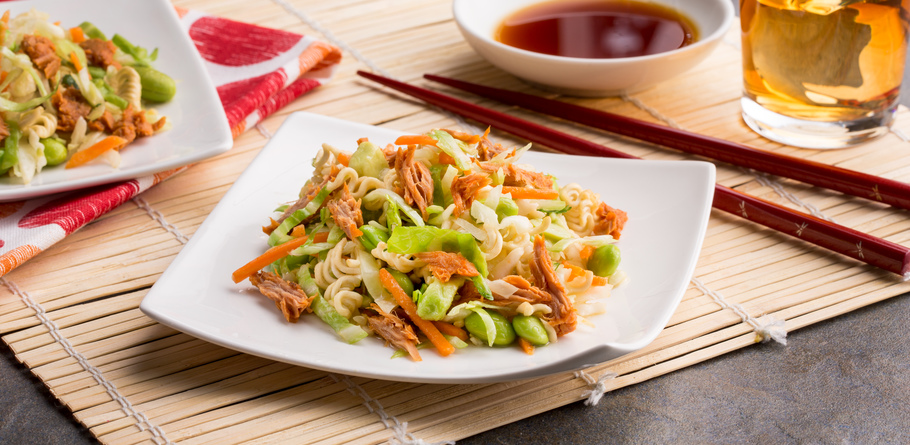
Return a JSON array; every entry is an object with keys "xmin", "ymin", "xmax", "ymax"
[{"xmin": 494, "ymin": 0, "xmax": 698, "ymax": 59}]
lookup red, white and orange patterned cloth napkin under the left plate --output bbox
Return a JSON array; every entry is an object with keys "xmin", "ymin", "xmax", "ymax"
[{"xmin": 0, "ymin": 8, "xmax": 341, "ymax": 276}]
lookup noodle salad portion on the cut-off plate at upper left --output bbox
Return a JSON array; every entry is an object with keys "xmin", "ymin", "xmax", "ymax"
[{"xmin": 0, "ymin": 9, "xmax": 176, "ymax": 184}]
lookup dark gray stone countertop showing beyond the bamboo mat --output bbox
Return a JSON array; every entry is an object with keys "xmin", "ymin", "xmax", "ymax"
[{"xmin": 0, "ymin": 15, "xmax": 910, "ymax": 445}]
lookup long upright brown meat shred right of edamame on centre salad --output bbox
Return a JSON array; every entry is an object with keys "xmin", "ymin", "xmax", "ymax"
[{"xmin": 531, "ymin": 236, "xmax": 577, "ymax": 336}]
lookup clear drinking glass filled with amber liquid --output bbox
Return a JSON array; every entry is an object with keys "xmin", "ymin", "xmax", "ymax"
[{"xmin": 740, "ymin": 0, "xmax": 910, "ymax": 149}]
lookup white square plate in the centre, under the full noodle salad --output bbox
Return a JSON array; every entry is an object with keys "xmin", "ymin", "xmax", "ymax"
[{"xmin": 140, "ymin": 113, "xmax": 714, "ymax": 383}]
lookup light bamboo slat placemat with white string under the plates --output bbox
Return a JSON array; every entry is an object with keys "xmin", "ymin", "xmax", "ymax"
[{"xmin": 0, "ymin": 0, "xmax": 910, "ymax": 444}]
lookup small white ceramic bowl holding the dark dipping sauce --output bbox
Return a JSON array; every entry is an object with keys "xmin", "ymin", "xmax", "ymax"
[{"xmin": 453, "ymin": 0, "xmax": 734, "ymax": 96}]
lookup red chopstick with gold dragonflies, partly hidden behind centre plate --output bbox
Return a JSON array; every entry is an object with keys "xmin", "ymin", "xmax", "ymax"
[{"xmin": 357, "ymin": 71, "xmax": 910, "ymax": 278}]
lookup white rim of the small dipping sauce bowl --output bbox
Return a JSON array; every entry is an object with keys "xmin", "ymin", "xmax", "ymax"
[{"xmin": 452, "ymin": 0, "xmax": 736, "ymax": 66}]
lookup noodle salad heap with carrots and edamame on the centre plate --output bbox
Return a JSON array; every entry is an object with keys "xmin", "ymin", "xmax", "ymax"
[{"xmin": 232, "ymin": 129, "xmax": 628, "ymax": 361}]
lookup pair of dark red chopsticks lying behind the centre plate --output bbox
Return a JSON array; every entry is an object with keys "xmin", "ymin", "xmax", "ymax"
[{"xmin": 357, "ymin": 71, "xmax": 910, "ymax": 279}]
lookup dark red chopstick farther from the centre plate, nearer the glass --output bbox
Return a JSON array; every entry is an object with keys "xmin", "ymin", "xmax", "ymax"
[{"xmin": 424, "ymin": 74, "xmax": 910, "ymax": 209}]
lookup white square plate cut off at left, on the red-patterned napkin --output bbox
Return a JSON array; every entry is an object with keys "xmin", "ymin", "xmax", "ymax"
[{"xmin": 0, "ymin": 0, "xmax": 232, "ymax": 201}]
